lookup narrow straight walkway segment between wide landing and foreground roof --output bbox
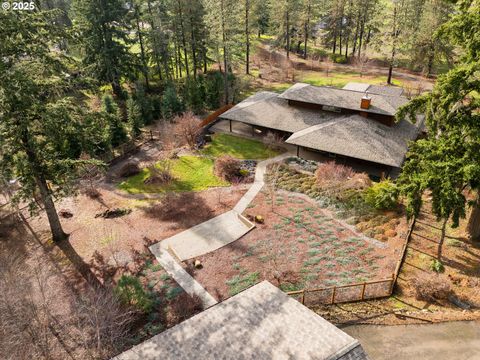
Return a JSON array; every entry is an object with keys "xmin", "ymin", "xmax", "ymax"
[{"xmin": 150, "ymin": 243, "xmax": 218, "ymax": 309}]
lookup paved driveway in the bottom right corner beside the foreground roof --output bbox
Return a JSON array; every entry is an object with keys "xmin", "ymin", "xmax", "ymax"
[{"xmin": 341, "ymin": 321, "xmax": 480, "ymax": 360}]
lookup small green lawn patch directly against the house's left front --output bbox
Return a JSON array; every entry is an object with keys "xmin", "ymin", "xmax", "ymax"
[{"xmin": 200, "ymin": 134, "xmax": 278, "ymax": 159}]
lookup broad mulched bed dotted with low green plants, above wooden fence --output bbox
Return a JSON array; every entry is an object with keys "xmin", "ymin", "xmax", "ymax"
[{"xmin": 185, "ymin": 192, "xmax": 401, "ymax": 299}]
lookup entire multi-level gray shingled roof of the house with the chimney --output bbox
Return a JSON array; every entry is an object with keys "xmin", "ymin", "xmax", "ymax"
[{"xmin": 220, "ymin": 83, "xmax": 423, "ymax": 167}]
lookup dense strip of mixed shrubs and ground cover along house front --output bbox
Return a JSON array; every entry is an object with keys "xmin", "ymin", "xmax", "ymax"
[{"xmin": 267, "ymin": 158, "xmax": 407, "ymax": 241}]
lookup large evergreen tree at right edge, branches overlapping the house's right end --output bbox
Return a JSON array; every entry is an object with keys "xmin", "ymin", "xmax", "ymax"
[{"xmin": 398, "ymin": 0, "xmax": 480, "ymax": 248}]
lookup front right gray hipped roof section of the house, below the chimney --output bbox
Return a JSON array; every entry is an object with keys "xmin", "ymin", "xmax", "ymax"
[{"xmin": 286, "ymin": 115, "xmax": 421, "ymax": 167}]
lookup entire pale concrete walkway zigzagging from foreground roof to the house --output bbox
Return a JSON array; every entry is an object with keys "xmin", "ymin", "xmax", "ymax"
[{"xmin": 149, "ymin": 153, "xmax": 291, "ymax": 308}]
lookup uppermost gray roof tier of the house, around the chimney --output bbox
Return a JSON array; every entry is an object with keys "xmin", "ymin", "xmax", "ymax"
[{"xmin": 279, "ymin": 83, "xmax": 408, "ymax": 116}]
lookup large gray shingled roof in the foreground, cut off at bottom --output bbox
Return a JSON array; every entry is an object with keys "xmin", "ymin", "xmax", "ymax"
[{"xmin": 116, "ymin": 281, "xmax": 368, "ymax": 360}]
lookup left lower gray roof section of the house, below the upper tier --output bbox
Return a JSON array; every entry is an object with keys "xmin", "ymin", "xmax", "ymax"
[{"xmin": 219, "ymin": 91, "xmax": 341, "ymax": 133}]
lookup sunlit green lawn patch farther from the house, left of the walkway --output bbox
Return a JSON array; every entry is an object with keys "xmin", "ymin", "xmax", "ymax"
[{"xmin": 118, "ymin": 156, "xmax": 229, "ymax": 194}]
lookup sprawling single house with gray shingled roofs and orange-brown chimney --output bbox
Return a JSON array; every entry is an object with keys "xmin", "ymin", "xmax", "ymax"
[{"xmin": 216, "ymin": 83, "xmax": 423, "ymax": 176}]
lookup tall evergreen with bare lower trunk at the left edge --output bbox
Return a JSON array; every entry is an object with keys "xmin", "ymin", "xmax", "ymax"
[{"xmin": 0, "ymin": 11, "xmax": 100, "ymax": 241}]
